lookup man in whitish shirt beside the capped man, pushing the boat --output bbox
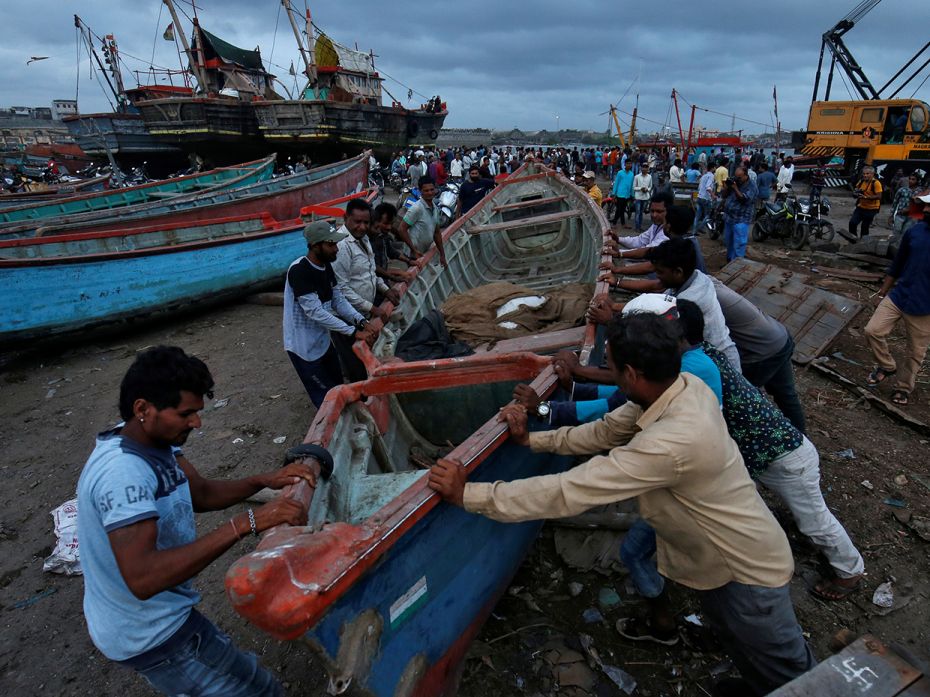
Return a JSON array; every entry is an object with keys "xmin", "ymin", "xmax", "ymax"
[{"xmin": 333, "ymin": 198, "xmax": 399, "ymax": 318}]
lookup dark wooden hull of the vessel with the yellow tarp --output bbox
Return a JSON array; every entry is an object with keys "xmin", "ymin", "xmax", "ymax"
[{"xmin": 252, "ymin": 99, "xmax": 447, "ymax": 150}]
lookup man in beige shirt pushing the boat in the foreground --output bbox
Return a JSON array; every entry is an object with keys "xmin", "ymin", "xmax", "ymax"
[{"xmin": 430, "ymin": 314, "xmax": 815, "ymax": 694}]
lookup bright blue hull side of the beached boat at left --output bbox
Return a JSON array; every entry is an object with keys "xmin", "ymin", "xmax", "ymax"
[{"xmin": 0, "ymin": 227, "xmax": 306, "ymax": 344}]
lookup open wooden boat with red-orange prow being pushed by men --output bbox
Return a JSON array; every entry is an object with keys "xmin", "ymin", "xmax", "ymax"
[{"xmin": 220, "ymin": 165, "xmax": 609, "ymax": 697}]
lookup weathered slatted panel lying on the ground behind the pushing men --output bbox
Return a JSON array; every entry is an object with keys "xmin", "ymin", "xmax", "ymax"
[{"xmin": 717, "ymin": 259, "xmax": 862, "ymax": 364}]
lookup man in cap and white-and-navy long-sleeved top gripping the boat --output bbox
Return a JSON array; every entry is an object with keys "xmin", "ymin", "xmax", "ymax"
[{"xmin": 284, "ymin": 220, "xmax": 374, "ymax": 407}]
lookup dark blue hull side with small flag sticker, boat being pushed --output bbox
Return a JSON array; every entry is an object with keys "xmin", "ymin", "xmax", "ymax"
[{"xmin": 305, "ymin": 441, "xmax": 571, "ymax": 697}]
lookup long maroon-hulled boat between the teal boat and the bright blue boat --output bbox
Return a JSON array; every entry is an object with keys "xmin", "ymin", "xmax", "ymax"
[{"xmin": 23, "ymin": 153, "xmax": 368, "ymax": 239}]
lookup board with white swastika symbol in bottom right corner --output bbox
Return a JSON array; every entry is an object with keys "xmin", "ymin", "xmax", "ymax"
[{"xmin": 770, "ymin": 634, "xmax": 922, "ymax": 697}]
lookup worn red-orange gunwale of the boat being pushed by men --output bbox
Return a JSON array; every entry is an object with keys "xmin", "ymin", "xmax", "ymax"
[{"xmin": 226, "ymin": 164, "xmax": 610, "ymax": 640}]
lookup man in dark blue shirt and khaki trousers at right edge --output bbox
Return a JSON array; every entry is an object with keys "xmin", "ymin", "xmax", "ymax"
[{"xmin": 865, "ymin": 195, "xmax": 930, "ymax": 406}]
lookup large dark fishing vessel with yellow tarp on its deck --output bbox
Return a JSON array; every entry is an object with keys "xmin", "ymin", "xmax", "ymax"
[{"xmin": 252, "ymin": 0, "xmax": 448, "ymax": 156}]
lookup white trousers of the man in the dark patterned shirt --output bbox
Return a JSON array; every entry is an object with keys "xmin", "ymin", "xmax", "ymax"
[{"xmin": 757, "ymin": 437, "xmax": 865, "ymax": 578}]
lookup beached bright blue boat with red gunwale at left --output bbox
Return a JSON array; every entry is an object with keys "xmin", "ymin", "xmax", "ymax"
[{"xmin": 0, "ymin": 190, "xmax": 377, "ymax": 346}]
